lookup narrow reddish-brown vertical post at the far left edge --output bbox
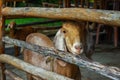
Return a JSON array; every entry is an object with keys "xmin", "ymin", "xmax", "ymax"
[{"xmin": 0, "ymin": 0, "xmax": 6, "ymax": 80}]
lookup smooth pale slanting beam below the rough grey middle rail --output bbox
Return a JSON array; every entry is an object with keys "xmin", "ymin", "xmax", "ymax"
[{"xmin": 0, "ymin": 54, "xmax": 73, "ymax": 80}]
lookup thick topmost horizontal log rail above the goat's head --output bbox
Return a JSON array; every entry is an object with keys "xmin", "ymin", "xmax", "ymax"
[{"xmin": 2, "ymin": 7, "xmax": 120, "ymax": 26}]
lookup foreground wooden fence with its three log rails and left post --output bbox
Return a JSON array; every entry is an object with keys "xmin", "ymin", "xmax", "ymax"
[{"xmin": 0, "ymin": 0, "xmax": 120, "ymax": 80}]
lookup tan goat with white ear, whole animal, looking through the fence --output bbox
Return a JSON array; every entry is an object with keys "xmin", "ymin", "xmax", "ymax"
[{"xmin": 24, "ymin": 21, "xmax": 94, "ymax": 80}]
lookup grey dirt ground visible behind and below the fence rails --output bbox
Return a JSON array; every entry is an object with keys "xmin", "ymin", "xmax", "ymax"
[{"xmin": 0, "ymin": 44, "xmax": 120, "ymax": 80}]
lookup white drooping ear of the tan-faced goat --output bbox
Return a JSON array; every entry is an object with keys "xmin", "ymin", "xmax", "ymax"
[{"xmin": 53, "ymin": 29, "xmax": 67, "ymax": 51}]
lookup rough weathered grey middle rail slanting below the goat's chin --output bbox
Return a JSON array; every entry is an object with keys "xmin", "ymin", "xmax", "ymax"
[{"xmin": 2, "ymin": 37, "xmax": 120, "ymax": 80}]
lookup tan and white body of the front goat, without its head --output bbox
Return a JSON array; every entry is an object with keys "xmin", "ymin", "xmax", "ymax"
[{"xmin": 24, "ymin": 33, "xmax": 80, "ymax": 80}]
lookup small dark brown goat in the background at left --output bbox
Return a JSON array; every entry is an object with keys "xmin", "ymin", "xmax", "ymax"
[{"xmin": 7, "ymin": 21, "xmax": 36, "ymax": 56}]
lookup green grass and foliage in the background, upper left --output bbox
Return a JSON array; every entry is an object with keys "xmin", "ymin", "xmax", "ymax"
[{"xmin": 5, "ymin": 0, "xmax": 62, "ymax": 26}]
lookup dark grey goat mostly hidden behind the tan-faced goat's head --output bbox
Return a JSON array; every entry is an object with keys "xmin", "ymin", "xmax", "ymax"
[{"xmin": 84, "ymin": 22, "xmax": 95, "ymax": 60}]
